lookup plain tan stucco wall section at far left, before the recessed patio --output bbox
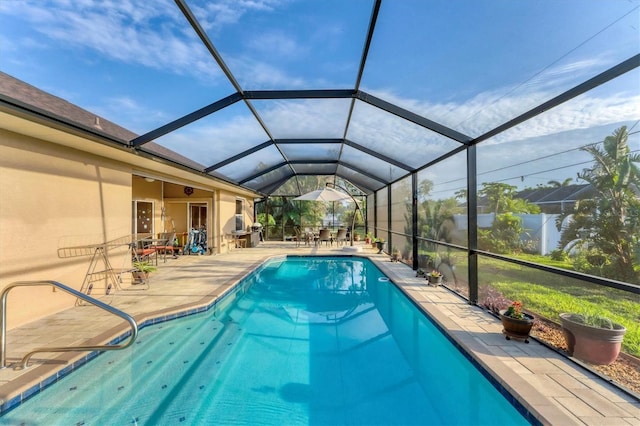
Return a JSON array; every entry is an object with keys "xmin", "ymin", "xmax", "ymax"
[{"xmin": 0, "ymin": 130, "xmax": 131, "ymax": 328}]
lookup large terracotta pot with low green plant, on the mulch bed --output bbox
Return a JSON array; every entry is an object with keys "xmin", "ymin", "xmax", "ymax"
[{"xmin": 560, "ymin": 313, "xmax": 627, "ymax": 365}]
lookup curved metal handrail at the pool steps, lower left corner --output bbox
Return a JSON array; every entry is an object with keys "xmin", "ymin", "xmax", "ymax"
[{"xmin": 0, "ymin": 280, "xmax": 138, "ymax": 370}]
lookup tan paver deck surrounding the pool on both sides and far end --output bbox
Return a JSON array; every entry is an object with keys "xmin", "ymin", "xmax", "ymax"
[{"xmin": 0, "ymin": 242, "xmax": 640, "ymax": 425}]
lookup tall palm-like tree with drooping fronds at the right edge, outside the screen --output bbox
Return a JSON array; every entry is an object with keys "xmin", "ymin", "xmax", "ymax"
[{"xmin": 572, "ymin": 126, "xmax": 640, "ymax": 282}]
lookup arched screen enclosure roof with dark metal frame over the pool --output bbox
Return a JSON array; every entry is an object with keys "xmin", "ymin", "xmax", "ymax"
[{"xmin": 0, "ymin": 0, "xmax": 640, "ymax": 195}]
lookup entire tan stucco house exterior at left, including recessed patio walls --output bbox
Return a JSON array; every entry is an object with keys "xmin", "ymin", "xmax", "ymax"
[{"xmin": 0, "ymin": 128, "xmax": 254, "ymax": 329}]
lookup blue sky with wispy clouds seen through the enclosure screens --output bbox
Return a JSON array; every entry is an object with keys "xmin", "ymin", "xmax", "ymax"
[{"xmin": 0, "ymin": 0, "xmax": 640, "ymax": 196}]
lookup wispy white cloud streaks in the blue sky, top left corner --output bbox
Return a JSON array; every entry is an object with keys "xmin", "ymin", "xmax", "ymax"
[{"xmin": 1, "ymin": 0, "xmax": 222, "ymax": 79}]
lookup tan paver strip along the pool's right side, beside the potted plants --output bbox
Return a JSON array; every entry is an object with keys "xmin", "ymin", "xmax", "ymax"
[{"xmin": 374, "ymin": 259, "xmax": 640, "ymax": 425}]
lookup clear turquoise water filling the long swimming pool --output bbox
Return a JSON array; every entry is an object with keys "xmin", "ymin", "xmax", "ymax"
[{"xmin": 0, "ymin": 257, "xmax": 528, "ymax": 425}]
